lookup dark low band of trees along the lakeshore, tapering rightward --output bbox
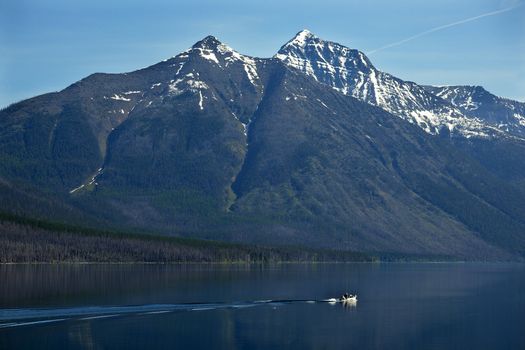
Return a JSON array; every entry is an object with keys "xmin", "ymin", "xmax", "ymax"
[{"xmin": 0, "ymin": 215, "xmax": 376, "ymax": 263}]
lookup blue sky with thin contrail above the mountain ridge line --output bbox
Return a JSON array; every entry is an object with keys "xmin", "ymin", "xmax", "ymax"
[{"xmin": 0, "ymin": 0, "xmax": 525, "ymax": 107}]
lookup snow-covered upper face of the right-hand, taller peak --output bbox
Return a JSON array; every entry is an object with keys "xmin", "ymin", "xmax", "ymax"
[{"xmin": 275, "ymin": 30, "xmax": 512, "ymax": 138}]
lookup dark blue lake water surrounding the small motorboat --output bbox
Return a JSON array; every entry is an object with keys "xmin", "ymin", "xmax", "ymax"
[{"xmin": 0, "ymin": 264, "xmax": 525, "ymax": 349}]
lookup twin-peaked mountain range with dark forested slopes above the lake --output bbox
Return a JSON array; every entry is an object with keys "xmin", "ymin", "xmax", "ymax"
[{"xmin": 0, "ymin": 30, "xmax": 525, "ymax": 259}]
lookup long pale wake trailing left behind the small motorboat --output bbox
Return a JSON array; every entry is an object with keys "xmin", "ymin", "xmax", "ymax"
[{"xmin": 0, "ymin": 299, "xmax": 354, "ymax": 329}]
